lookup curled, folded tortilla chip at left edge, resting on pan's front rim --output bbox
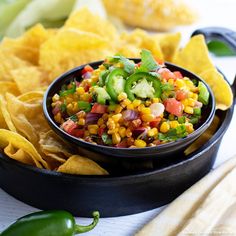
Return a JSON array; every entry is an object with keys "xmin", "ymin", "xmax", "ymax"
[{"xmin": 0, "ymin": 129, "xmax": 48, "ymax": 169}]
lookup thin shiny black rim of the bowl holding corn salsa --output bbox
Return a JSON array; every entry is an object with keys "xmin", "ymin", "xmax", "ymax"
[{"xmin": 43, "ymin": 58, "xmax": 216, "ymax": 153}]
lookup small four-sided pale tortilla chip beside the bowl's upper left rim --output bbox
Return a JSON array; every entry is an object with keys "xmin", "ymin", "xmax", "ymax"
[{"xmin": 11, "ymin": 66, "xmax": 45, "ymax": 93}]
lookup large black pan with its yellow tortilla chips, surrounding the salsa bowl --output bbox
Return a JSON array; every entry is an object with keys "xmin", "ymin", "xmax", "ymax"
[{"xmin": 0, "ymin": 9, "xmax": 233, "ymax": 216}]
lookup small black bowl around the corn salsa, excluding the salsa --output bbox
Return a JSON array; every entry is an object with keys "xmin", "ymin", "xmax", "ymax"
[{"xmin": 43, "ymin": 59, "xmax": 215, "ymax": 161}]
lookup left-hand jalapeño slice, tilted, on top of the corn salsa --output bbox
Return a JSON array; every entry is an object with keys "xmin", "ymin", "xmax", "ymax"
[{"xmin": 106, "ymin": 68, "xmax": 128, "ymax": 102}]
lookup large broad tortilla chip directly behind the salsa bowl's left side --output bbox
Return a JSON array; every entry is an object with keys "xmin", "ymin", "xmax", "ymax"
[{"xmin": 40, "ymin": 28, "xmax": 111, "ymax": 80}]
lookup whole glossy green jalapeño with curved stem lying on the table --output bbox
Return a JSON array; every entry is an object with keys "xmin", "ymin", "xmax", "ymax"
[{"xmin": 0, "ymin": 210, "xmax": 99, "ymax": 236}]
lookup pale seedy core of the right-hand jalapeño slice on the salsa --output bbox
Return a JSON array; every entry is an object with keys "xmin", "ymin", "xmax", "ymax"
[{"xmin": 131, "ymin": 78, "xmax": 155, "ymax": 98}]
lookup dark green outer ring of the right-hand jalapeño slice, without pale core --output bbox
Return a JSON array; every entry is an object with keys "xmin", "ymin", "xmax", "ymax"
[{"xmin": 125, "ymin": 72, "xmax": 161, "ymax": 101}]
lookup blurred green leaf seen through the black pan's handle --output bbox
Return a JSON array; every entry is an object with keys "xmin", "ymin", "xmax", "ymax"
[{"xmin": 207, "ymin": 40, "xmax": 236, "ymax": 57}]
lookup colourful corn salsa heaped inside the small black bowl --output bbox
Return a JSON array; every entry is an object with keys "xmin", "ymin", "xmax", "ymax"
[{"xmin": 51, "ymin": 50, "xmax": 209, "ymax": 148}]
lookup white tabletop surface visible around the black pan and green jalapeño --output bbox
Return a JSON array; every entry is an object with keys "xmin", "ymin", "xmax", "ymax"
[{"xmin": 0, "ymin": 0, "xmax": 236, "ymax": 236}]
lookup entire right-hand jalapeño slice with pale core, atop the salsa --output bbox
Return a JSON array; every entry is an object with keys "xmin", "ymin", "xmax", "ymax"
[{"xmin": 125, "ymin": 72, "xmax": 161, "ymax": 101}]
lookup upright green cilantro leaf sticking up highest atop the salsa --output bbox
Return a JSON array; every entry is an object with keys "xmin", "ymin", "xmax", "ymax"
[{"xmin": 137, "ymin": 49, "xmax": 160, "ymax": 72}]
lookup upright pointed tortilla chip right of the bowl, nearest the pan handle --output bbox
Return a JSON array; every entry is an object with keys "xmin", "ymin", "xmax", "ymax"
[{"xmin": 173, "ymin": 35, "xmax": 215, "ymax": 75}]
